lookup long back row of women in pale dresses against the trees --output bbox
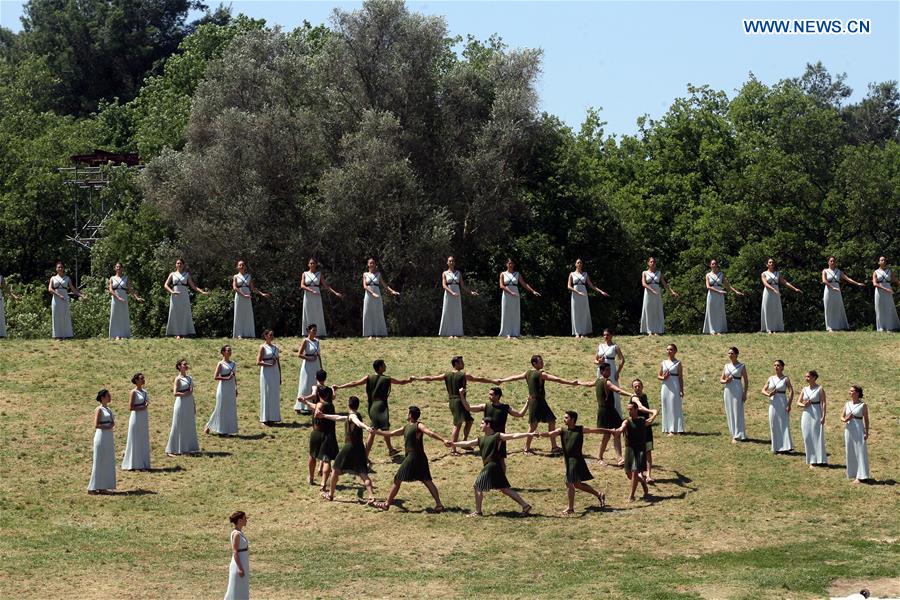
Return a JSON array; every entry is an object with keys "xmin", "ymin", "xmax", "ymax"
[{"xmin": 0, "ymin": 256, "xmax": 900, "ymax": 339}]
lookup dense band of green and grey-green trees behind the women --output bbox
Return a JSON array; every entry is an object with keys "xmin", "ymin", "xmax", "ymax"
[{"xmin": 0, "ymin": 0, "xmax": 900, "ymax": 335}]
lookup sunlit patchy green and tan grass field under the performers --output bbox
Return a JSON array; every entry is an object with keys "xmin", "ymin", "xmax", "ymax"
[{"xmin": 0, "ymin": 333, "xmax": 900, "ymax": 598}]
